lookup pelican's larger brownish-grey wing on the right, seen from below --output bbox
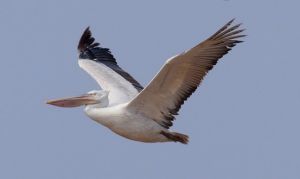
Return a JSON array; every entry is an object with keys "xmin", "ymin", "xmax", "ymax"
[{"xmin": 128, "ymin": 20, "xmax": 245, "ymax": 128}]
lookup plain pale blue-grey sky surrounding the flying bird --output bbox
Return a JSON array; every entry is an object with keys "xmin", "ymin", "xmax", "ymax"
[{"xmin": 0, "ymin": 0, "xmax": 300, "ymax": 179}]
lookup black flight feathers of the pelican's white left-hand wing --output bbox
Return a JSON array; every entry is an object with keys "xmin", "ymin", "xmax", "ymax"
[{"xmin": 77, "ymin": 27, "xmax": 143, "ymax": 92}]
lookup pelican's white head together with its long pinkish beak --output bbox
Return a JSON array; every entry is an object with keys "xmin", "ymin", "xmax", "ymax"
[{"xmin": 47, "ymin": 90, "xmax": 109, "ymax": 108}]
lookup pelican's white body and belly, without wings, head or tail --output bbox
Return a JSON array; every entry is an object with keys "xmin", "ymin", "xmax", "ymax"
[{"xmin": 85, "ymin": 104, "xmax": 170, "ymax": 142}]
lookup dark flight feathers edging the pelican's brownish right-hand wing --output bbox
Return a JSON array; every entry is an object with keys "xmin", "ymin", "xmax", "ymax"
[{"xmin": 162, "ymin": 19, "xmax": 246, "ymax": 128}]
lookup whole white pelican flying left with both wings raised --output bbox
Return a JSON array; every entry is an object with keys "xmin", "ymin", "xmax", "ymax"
[{"xmin": 47, "ymin": 19, "xmax": 245, "ymax": 144}]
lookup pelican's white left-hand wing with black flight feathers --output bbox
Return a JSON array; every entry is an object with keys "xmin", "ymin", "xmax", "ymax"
[{"xmin": 78, "ymin": 27, "xmax": 143, "ymax": 106}]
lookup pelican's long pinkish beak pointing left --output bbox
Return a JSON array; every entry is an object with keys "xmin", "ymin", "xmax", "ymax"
[{"xmin": 47, "ymin": 94, "xmax": 99, "ymax": 108}]
